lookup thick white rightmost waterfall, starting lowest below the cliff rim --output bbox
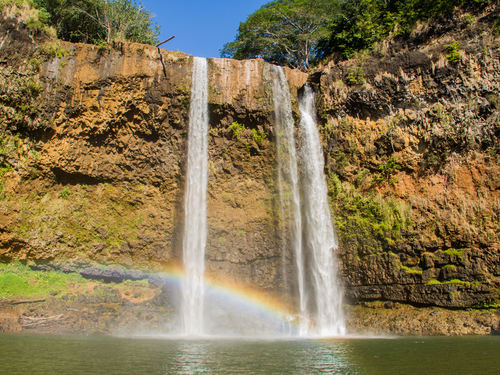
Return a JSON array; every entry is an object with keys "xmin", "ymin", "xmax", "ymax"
[{"xmin": 299, "ymin": 85, "xmax": 346, "ymax": 336}]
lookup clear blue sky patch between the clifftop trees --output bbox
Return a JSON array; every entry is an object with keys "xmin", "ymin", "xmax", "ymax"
[{"xmin": 145, "ymin": 0, "xmax": 270, "ymax": 57}]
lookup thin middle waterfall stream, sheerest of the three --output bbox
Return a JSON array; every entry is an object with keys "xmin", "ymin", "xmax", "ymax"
[{"xmin": 270, "ymin": 65, "xmax": 309, "ymax": 335}]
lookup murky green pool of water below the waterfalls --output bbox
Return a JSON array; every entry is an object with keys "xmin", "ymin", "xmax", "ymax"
[{"xmin": 0, "ymin": 334, "xmax": 500, "ymax": 375}]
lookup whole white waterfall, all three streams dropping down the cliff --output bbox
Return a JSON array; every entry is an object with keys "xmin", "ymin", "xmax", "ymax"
[{"xmin": 181, "ymin": 57, "xmax": 346, "ymax": 337}]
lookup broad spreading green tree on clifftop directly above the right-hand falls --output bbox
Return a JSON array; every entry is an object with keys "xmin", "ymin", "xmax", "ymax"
[{"xmin": 221, "ymin": 0, "xmax": 338, "ymax": 70}]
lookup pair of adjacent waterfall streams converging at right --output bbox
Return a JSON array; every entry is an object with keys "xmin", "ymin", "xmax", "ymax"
[{"xmin": 270, "ymin": 66, "xmax": 346, "ymax": 336}]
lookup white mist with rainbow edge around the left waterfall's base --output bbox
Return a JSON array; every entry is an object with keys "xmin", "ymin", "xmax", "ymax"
[{"xmin": 148, "ymin": 273, "xmax": 298, "ymax": 340}]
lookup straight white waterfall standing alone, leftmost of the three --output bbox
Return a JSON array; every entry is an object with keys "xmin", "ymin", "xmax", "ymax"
[{"xmin": 182, "ymin": 57, "xmax": 208, "ymax": 335}]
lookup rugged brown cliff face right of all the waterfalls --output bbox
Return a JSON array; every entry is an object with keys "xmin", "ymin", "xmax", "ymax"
[{"xmin": 311, "ymin": 11, "xmax": 500, "ymax": 308}]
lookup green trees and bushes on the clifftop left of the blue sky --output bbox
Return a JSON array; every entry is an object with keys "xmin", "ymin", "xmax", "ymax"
[{"xmin": 35, "ymin": 0, "xmax": 160, "ymax": 44}]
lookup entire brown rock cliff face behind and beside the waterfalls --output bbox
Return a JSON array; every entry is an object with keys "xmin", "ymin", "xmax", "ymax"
[{"xmin": 0, "ymin": 8, "xmax": 500, "ymax": 324}]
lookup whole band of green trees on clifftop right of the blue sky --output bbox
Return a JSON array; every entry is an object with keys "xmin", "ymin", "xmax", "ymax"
[{"xmin": 221, "ymin": 0, "xmax": 493, "ymax": 70}]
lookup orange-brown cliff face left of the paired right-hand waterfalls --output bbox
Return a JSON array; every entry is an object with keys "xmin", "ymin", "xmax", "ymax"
[{"xmin": 0, "ymin": 19, "xmax": 307, "ymax": 300}]
